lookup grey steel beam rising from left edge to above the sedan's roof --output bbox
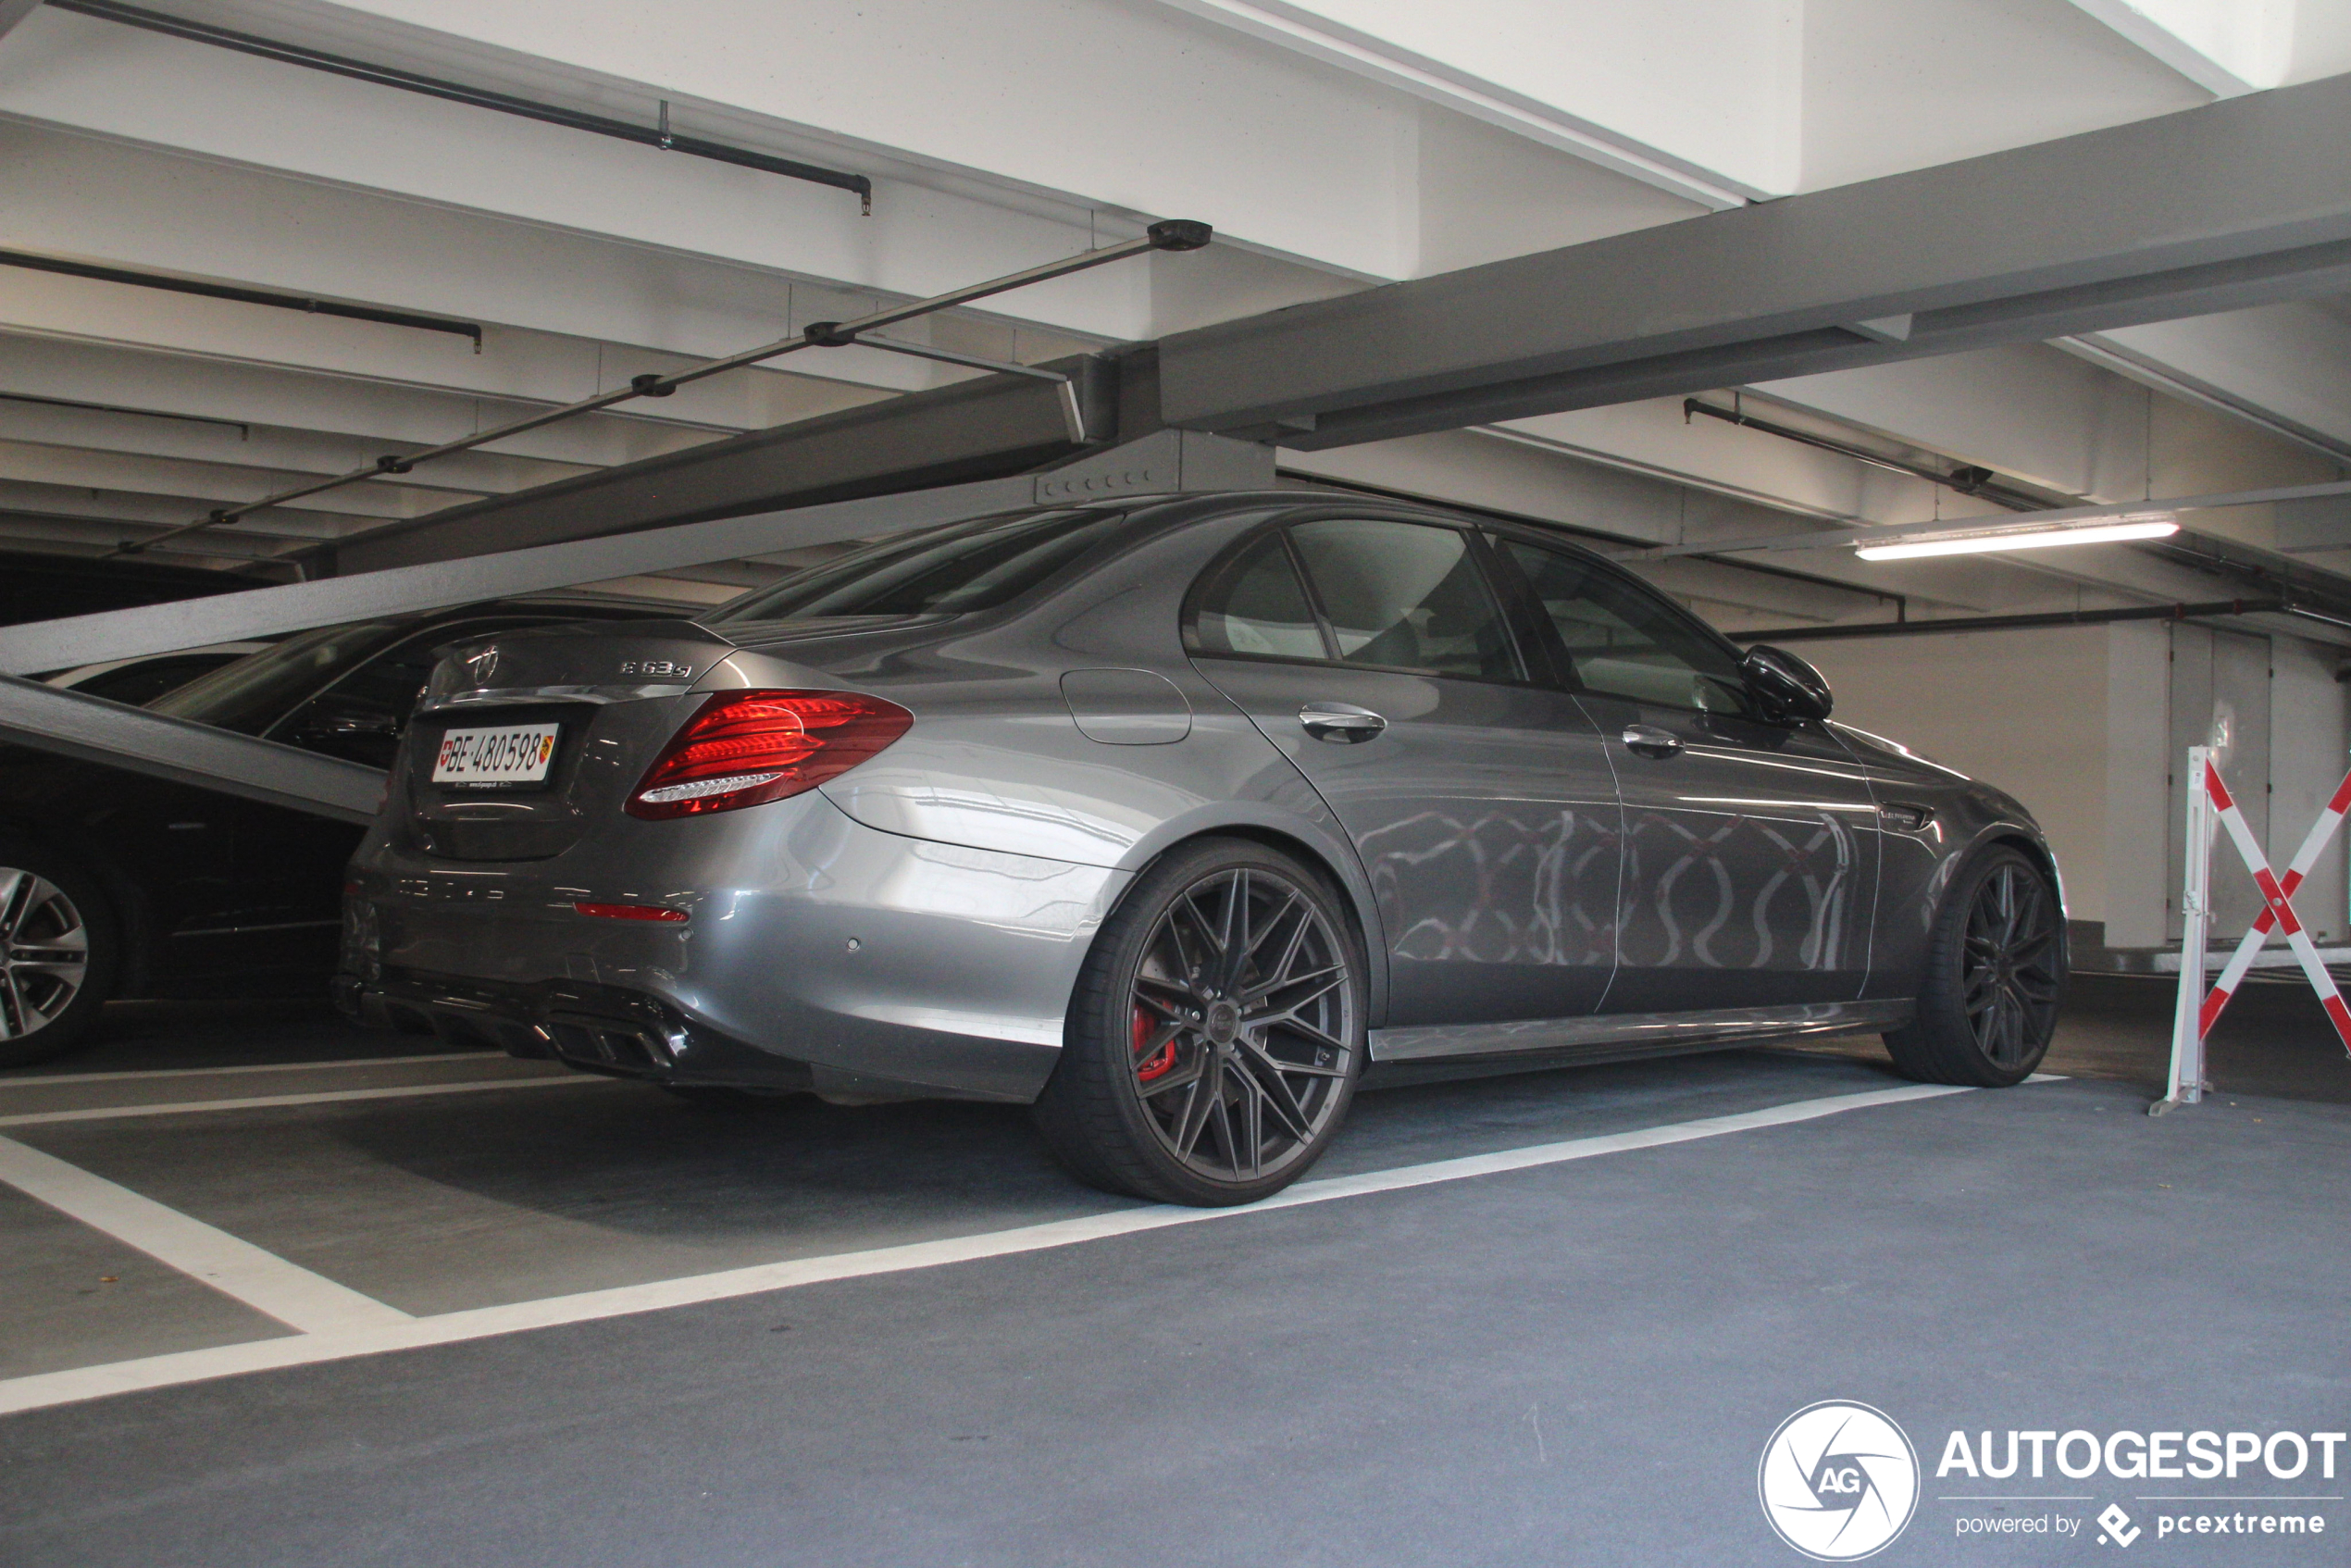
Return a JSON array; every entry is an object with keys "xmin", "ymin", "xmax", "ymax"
[{"xmin": 0, "ymin": 429, "xmax": 1275, "ymax": 675}]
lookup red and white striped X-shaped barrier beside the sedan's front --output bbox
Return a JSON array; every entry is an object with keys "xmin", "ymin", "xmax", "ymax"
[{"xmin": 2151, "ymin": 745, "xmax": 2351, "ymax": 1114}]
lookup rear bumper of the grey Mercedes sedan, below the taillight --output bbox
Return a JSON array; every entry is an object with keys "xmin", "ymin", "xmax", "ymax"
[{"xmin": 336, "ymin": 792, "xmax": 1126, "ymax": 1102}]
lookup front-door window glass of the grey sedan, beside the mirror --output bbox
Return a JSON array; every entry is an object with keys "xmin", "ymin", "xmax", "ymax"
[{"xmin": 1505, "ymin": 541, "xmax": 1754, "ymax": 715}]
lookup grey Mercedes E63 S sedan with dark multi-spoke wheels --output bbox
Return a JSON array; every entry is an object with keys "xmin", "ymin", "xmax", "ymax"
[{"xmin": 336, "ymin": 492, "xmax": 2067, "ymax": 1203}]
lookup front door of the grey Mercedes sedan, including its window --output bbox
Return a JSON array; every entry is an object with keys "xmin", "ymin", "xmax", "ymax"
[{"xmin": 1500, "ymin": 536, "xmax": 1878, "ymax": 1014}]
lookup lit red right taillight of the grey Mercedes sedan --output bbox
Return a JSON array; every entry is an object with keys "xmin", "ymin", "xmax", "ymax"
[{"xmin": 628, "ymin": 691, "xmax": 914, "ymax": 820}]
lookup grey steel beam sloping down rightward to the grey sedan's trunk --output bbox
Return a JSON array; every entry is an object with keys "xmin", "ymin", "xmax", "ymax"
[{"xmin": 0, "ymin": 677, "xmax": 383, "ymax": 823}]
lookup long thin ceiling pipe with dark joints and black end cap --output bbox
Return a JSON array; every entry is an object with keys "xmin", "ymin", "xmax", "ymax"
[{"xmin": 106, "ymin": 223, "xmax": 1213, "ymax": 557}]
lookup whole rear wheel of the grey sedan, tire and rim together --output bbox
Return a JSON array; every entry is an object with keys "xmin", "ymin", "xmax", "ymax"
[{"xmin": 1035, "ymin": 840, "xmax": 1366, "ymax": 1208}]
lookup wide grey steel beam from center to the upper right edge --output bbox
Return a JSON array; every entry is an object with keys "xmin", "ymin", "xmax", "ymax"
[{"xmin": 1159, "ymin": 75, "xmax": 2351, "ymax": 449}]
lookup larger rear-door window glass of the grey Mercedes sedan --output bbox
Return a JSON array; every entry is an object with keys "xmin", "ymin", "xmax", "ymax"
[{"xmin": 1290, "ymin": 517, "xmax": 1519, "ymax": 679}]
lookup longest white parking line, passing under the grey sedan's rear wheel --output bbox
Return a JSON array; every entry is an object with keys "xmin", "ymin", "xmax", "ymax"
[{"xmin": 0, "ymin": 1084, "xmax": 2003, "ymax": 1415}]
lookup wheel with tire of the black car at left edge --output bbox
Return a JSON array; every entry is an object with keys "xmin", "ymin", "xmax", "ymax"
[{"xmin": 0, "ymin": 840, "xmax": 122, "ymax": 1067}]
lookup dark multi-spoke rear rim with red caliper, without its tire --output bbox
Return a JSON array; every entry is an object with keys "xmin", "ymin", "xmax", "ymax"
[{"xmin": 1128, "ymin": 867, "xmax": 1357, "ymax": 1182}]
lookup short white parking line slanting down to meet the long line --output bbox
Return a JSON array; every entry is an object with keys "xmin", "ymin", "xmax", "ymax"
[{"xmin": 0, "ymin": 1138, "xmax": 417, "ymax": 1338}]
